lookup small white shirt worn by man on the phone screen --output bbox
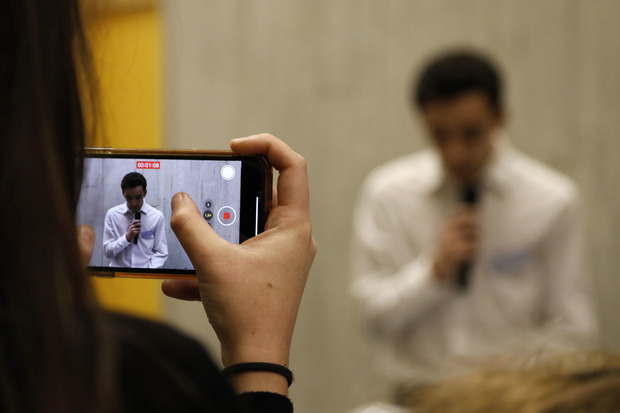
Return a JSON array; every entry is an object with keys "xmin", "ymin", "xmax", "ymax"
[{"xmin": 103, "ymin": 202, "xmax": 168, "ymax": 268}]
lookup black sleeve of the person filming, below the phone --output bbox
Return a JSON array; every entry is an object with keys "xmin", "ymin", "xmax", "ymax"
[{"xmin": 109, "ymin": 314, "xmax": 293, "ymax": 413}]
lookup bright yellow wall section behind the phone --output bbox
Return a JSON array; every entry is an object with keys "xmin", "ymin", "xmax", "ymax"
[{"xmin": 91, "ymin": 6, "xmax": 162, "ymax": 318}]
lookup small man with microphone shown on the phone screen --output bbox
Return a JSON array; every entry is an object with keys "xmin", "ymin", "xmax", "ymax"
[{"xmin": 103, "ymin": 172, "xmax": 168, "ymax": 268}]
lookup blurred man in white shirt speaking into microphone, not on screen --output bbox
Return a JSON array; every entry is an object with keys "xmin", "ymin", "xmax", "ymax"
[{"xmin": 352, "ymin": 53, "xmax": 597, "ymax": 381}]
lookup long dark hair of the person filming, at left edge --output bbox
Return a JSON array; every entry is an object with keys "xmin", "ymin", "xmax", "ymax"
[{"xmin": 0, "ymin": 0, "xmax": 107, "ymax": 412}]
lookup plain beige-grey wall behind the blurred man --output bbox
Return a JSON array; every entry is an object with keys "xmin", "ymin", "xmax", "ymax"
[{"xmin": 159, "ymin": 0, "xmax": 620, "ymax": 413}]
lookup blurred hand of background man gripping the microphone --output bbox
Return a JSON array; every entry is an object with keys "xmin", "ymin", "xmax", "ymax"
[{"xmin": 433, "ymin": 207, "xmax": 479, "ymax": 281}]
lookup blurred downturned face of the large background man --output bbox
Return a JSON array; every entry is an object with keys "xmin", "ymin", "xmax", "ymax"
[{"xmin": 422, "ymin": 91, "xmax": 503, "ymax": 184}]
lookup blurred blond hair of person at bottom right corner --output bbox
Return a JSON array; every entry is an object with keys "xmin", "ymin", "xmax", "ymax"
[{"xmin": 409, "ymin": 352, "xmax": 620, "ymax": 413}]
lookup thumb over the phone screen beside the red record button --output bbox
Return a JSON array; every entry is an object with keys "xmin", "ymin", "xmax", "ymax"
[{"xmin": 170, "ymin": 192, "xmax": 229, "ymax": 269}]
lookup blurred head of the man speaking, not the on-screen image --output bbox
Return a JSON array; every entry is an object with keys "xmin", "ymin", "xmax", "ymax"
[{"xmin": 412, "ymin": 52, "xmax": 504, "ymax": 183}]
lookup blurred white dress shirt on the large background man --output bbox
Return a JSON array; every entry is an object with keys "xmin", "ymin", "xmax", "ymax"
[{"xmin": 352, "ymin": 142, "xmax": 598, "ymax": 380}]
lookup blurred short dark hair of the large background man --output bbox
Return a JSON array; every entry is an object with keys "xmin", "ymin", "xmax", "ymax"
[{"xmin": 411, "ymin": 51, "xmax": 503, "ymax": 112}]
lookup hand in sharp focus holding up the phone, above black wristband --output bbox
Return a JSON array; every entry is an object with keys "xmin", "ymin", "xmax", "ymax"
[{"xmin": 162, "ymin": 134, "xmax": 316, "ymax": 391}]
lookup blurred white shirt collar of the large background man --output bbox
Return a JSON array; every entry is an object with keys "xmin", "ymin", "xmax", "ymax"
[{"xmin": 422, "ymin": 131, "xmax": 511, "ymax": 194}]
